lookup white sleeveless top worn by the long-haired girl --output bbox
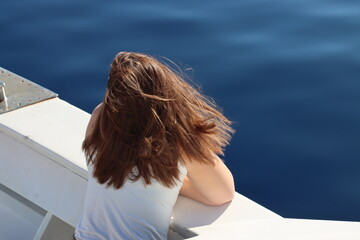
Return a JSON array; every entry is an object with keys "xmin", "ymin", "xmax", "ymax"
[{"xmin": 75, "ymin": 164, "xmax": 186, "ymax": 240}]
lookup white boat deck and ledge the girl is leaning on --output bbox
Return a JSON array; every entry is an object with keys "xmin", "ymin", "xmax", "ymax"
[{"xmin": 0, "ymin": 69, "xmax": 360, "ymax": 240}]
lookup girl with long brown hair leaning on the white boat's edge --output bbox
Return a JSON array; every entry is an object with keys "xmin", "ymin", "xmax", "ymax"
[{"xmin": 75, "ymin": 52, "xmax": 235, "ymax": 240}]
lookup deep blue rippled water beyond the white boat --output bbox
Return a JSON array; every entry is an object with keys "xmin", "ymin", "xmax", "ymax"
[{"xmin": 0, "ymin": 0, "xmax": 360, "ymax": 221}]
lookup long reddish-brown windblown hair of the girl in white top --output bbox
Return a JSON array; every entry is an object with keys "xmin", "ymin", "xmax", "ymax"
[{"xmin": 83, "ymin": 52, "xmax": 233, "ymax": 189}]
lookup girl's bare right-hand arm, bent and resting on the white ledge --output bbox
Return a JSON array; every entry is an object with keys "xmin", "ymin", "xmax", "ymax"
[{"xmin": 180, "ymin": 156, "xmax": 235, "ymax": 206}]
